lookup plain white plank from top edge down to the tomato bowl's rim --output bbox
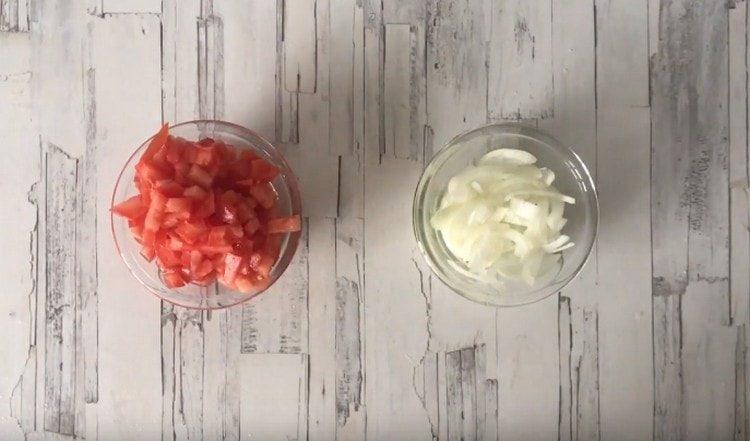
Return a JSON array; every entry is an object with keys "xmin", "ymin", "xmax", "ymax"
[{"xmin": 214, "ymin": 0, "xmax": 276, "ymax": 141}]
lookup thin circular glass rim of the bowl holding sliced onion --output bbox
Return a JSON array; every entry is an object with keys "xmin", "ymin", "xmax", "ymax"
[{"xmin": 412, "ymin": 122, "xmax": 600, "ymax": 308}]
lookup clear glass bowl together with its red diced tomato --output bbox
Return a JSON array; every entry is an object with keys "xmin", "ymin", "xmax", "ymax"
[{"xmin": 111, "ymin": 120, "xmax": 301, "ymax": 309}]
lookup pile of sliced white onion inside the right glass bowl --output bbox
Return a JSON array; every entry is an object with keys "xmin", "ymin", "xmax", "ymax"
[{"xmin": 430, "ymin": 148, "xmax": 576, "ymax": 286}]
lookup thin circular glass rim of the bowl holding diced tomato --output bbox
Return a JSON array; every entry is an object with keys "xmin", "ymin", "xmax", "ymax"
[{"xmin": 109, "ymin": 119, "xmax": 302, "ymax": 311}]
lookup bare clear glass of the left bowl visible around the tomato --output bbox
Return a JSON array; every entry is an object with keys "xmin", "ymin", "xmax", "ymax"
[{"xmin": 111, "ymin": 120, "xmax": 301, "ymax": 309}]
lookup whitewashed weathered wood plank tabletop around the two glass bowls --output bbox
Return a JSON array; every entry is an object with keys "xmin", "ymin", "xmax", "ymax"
[{"xmin": 0, "ymin": 0, "xmax": 750, "ymax": 441}]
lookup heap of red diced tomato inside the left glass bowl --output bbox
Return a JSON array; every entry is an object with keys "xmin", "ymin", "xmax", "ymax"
[{"xmin": 111, "ymin": 125, "xmax": 302, "ymax": 293}]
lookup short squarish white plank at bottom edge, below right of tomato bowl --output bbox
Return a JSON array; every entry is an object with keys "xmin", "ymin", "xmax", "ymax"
[{"xmin": 240, "ymin": 354, "xmax": 307, "ymax": 441}]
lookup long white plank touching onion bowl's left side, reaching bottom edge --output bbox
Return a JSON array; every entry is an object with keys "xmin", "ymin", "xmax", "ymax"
[{"xmin": 364, "ymin": 157, "xmax": 430, "ymax": 439}]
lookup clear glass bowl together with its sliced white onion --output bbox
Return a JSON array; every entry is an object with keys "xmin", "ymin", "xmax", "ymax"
[{"xmin": 413, "ymin": 123, "xmax": 599, "ymax": 306}]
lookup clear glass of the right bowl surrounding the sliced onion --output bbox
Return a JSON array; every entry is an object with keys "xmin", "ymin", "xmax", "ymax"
[{"xmin": 413, "ymin": 123, "xmax": 599, "ymax": 306}]
